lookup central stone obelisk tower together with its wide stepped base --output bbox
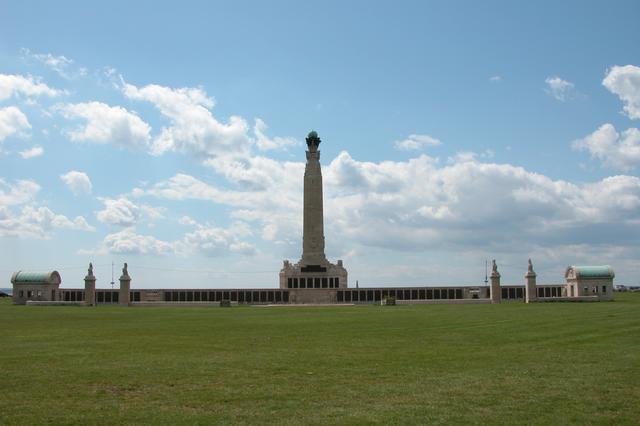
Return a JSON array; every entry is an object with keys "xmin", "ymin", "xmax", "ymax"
[{"xmin": 280, "ymin": 131, "xmax": 347, "ymax": 299}]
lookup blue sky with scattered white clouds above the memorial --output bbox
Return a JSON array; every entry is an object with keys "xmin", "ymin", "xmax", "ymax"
[{"xmin": 0, "ymin": 1, "xmax": 640, "ymax": 287}]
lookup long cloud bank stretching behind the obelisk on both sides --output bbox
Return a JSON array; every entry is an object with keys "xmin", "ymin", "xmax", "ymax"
[{"xmin": 139, "ymin": 152, "xmax": 640, "ymax": 258}]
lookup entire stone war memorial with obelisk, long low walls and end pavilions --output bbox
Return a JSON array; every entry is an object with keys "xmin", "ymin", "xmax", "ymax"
[{"xmin": 11, "ymin": 131, "xmax": 615, "ymax": 306}]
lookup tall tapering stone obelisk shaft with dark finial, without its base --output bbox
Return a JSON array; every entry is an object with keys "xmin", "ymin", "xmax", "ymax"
[{"xmin": 300, "ymin": 131, "xmax": 328, "ymax": 269}]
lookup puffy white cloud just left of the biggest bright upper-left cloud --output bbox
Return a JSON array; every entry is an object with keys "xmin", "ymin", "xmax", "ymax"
[{"xmin": 56, "ymin": 102, "xmax": 151, "ymax": 149}]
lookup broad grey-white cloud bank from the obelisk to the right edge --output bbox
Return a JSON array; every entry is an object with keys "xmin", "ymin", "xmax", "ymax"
[{"xmin": 325, "ymin": 153, "xmax": 640, "ymax": 253}]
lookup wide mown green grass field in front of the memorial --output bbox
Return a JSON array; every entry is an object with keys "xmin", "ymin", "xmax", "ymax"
[{"xmin": 0, "ymin": 293, "xmax": 640, "ymax": 424}]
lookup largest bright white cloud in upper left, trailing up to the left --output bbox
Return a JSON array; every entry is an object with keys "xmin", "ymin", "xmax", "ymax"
[{"xmin": 122, "ymin": 82, "xmax": 251, "ymax": 159}]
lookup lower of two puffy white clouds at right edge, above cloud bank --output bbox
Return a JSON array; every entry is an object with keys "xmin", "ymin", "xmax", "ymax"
[{"xmin": 572, "ymin": 123, "xmax": 640, "ymax": 171}]
